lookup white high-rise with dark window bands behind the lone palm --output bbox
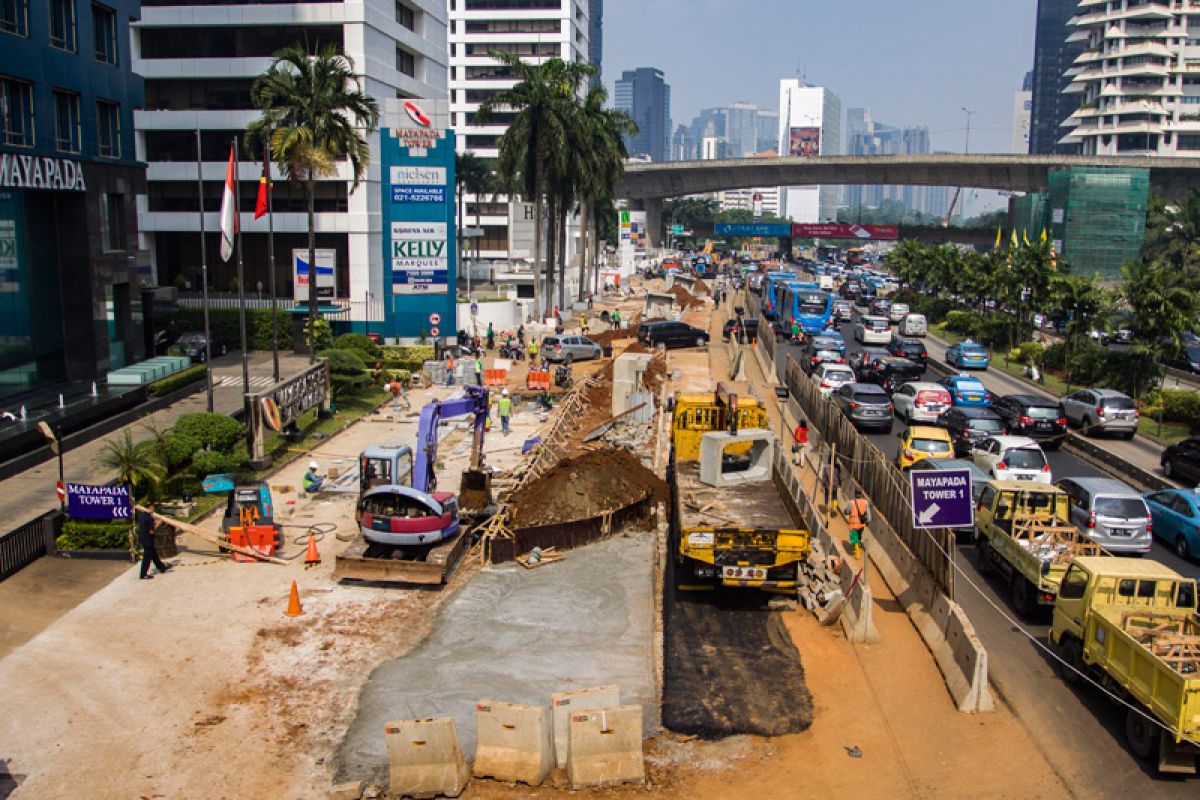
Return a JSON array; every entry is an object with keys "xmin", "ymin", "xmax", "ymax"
[{"xmin": 133, "ymin": 0, "xmax": 446, "ymax": 321}]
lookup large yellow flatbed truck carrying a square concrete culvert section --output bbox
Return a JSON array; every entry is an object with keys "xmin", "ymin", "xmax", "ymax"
[{"xmin": 667, "ymin": 384, "xmax": 810, "ymax": 595}]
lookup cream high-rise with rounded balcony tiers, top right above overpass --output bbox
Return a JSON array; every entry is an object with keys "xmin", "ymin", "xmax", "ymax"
[{"xmin": 1061, "ymin": 0, "xmax": 1200, "ymax": 156}]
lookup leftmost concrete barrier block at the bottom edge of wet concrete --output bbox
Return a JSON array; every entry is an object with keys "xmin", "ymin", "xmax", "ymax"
[{"xmin": 384, "ymin": 717, "xmax": 470, "ymax": 798}]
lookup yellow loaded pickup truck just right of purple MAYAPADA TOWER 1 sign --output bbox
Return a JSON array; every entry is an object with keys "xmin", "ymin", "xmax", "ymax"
[{"xmin": 976, "ymin": 481, "xmax": 1103, "ymax": 616}]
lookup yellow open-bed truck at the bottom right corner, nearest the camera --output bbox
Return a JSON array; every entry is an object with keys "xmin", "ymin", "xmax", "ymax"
[{"xmin": 1050, "ymin": 557, "xmax": 1200, "ymax": 775}]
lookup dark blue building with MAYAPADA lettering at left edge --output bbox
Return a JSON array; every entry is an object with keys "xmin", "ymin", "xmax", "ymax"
[{"xmin": 0, "ymin": 0, "xmax": 148, "ymax": 393}]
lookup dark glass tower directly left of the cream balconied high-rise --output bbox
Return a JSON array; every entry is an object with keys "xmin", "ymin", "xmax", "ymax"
[{"xmin": 1028, "ymin": 0, "xmax": 1084, "ymax": 155}]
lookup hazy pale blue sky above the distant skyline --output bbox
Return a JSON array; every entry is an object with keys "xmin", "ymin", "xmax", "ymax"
[{"xmin": 602, "ymin": 0, "xmax": 1037, "ymax": 152}]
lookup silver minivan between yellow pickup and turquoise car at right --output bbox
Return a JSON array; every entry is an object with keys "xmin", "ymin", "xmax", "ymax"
[{"xmin": 1055, "ymin": 477, "xmax": 1153, "ymax": 555}]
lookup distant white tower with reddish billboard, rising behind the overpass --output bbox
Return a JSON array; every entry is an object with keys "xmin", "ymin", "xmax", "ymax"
[{"xmin": 779, "ymin": 78, "xmax": 841, "ymax": 222}]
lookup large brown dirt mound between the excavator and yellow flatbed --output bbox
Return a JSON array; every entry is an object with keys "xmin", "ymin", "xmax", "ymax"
[{"xmin": 510, "ymin": 450, "xmax": 668, "ymax": 528}]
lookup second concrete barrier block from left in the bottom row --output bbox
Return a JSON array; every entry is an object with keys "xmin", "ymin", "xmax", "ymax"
[{"xmin": 472, "ymin": 700, "xmax": 554, "ymax": 786}]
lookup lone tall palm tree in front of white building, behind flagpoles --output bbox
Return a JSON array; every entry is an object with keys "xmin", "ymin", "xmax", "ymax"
[{"xmin": 246, "ymin": 44, "xmax": 379, "ymax": 360}]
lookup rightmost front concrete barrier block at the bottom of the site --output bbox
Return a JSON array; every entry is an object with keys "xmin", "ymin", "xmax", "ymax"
[{"xmin": 566, "ymin": 705, "xmax": 646, "ymax": 789}]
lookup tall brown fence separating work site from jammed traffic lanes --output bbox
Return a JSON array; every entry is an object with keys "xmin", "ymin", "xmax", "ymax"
[{"xmin": 787, "ymin": 357, "xmax": 954, "ymax": 600}]
